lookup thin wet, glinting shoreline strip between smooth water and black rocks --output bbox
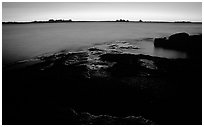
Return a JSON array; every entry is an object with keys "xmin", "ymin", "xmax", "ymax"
[{"xmin": 3, "ymin": 33, "xmax": 194, "ymax": 67}]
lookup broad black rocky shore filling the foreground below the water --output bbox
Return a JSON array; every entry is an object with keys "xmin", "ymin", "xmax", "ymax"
[{"xmin": 2, "ymin": 33, "xmax": 202, "ymax": 125}]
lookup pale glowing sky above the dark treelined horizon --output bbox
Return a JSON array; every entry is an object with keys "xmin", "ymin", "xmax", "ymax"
[{"xmin": 2, "ymin": 2, "xmax": 202, "ymax": 22}]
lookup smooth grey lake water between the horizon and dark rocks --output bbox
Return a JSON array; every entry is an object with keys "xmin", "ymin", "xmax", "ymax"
[{"xmin": 2, "ymin": 22, "xmax": 202, "ymax": 65}]
